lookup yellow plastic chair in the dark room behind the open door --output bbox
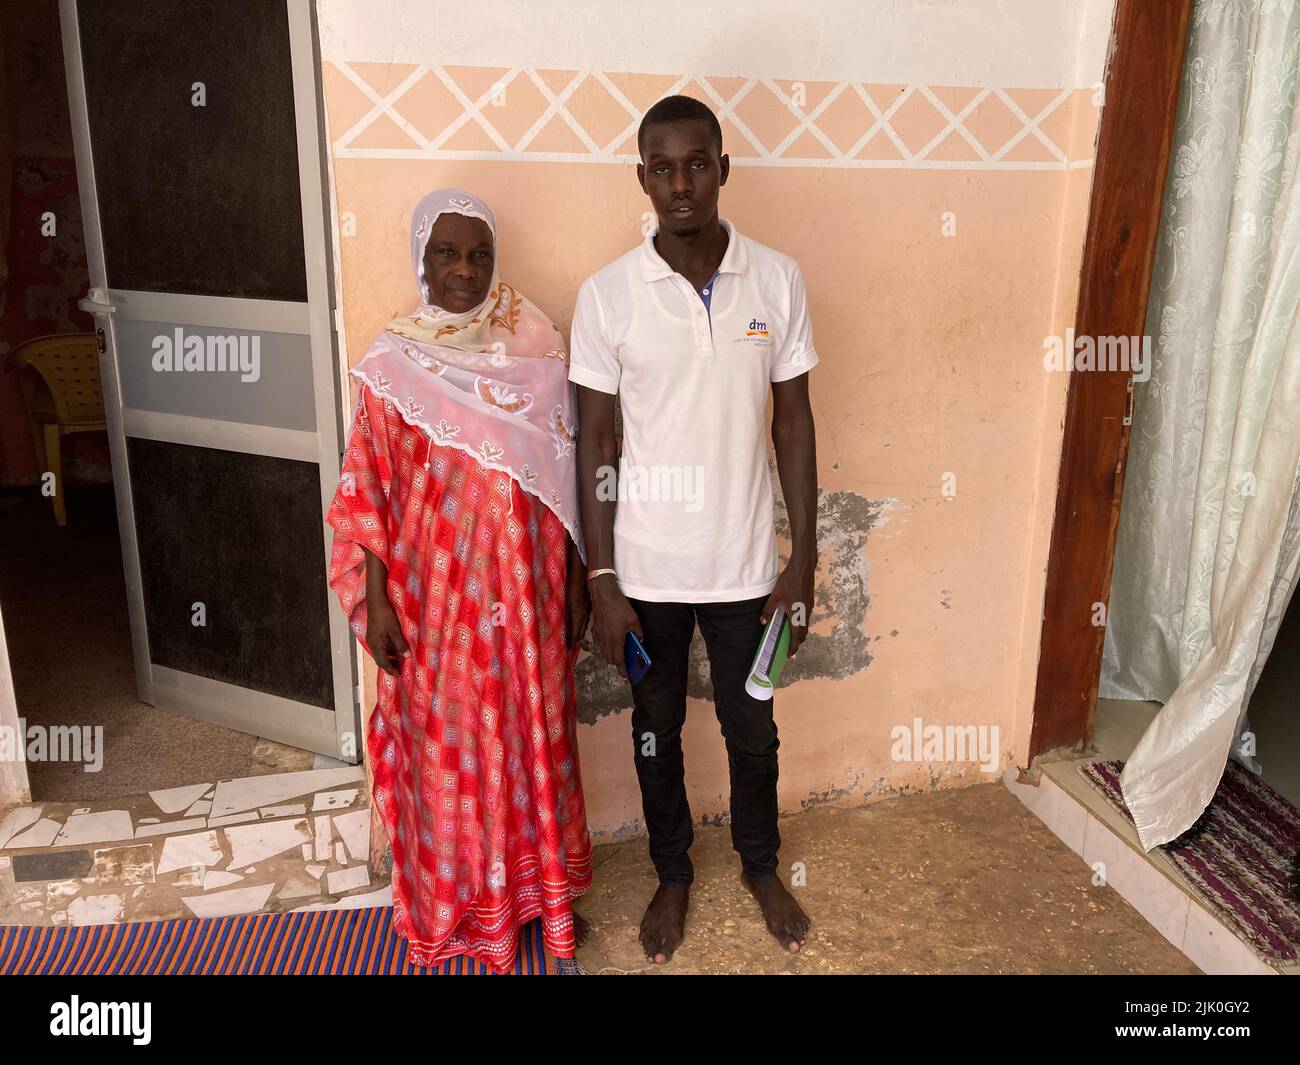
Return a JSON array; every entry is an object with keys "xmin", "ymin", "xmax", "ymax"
[{"xmin": 13, "ymin": 333, "xmax": 108, "ymax": 525}]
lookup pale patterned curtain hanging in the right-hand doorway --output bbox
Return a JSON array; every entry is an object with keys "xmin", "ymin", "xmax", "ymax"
[{"xmin": 1100, "ymin": 0, "xmax": 1300, "ymax": 849}]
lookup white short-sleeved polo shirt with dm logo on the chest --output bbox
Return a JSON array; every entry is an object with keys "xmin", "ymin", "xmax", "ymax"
[{"xmin": 569, "ymin": 218, "xmax": 818, "ymax": 602}]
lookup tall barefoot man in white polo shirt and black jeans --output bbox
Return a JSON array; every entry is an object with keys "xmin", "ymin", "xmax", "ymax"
[{"xmin": 569, "ymin": 96, "xmax": 818, "ymax": 962}]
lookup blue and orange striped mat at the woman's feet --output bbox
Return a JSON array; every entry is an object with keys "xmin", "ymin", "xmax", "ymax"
[{"xmin": 0, "ymin": 906, "xmax": 546, "ymax": 977}]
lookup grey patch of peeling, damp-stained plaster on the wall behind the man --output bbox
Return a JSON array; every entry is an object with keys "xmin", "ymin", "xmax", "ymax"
[{"xmin": 575, "ymin": 481, "xmax": 892, "ymax": 724}]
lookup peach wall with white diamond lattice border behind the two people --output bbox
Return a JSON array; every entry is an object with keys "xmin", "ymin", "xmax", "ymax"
[{"xmin": 321, "ymin": 0, "xmax": 1110, "ymax": 836}]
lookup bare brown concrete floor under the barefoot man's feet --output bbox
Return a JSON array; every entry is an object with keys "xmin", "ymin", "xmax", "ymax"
[{"xmin": 577, "ymin": 784, "xmax": 1200, "ymax": 975}]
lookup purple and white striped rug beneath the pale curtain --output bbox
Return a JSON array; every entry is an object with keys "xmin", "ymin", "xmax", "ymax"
[{"xmin": 1079, "ymin": 759, "xmax": 1300, "ymax": 964}]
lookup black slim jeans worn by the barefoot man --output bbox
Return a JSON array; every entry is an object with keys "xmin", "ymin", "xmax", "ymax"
[{"xmin": 629, "ymin": 596, "xmax": 781, "ymax": 884}]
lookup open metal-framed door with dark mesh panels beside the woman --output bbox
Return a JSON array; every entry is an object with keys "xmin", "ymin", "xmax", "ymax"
[{"xmin": 60, "ymin": 0, "xmax": 360, "ymax": 762}]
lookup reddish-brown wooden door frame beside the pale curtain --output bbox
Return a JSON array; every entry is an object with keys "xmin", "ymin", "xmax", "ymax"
[{"xmin": 1028, "ymin": 0, "xmax": 1192, "ymax": 762}]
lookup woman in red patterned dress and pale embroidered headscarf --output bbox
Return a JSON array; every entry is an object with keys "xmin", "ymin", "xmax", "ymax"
[{"xmin": 328, "ymin": 189, "xmax": 592, "ymax": 970}]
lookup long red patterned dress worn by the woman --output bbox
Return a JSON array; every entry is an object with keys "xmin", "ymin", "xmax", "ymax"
[{"xmin": 328, "ymin": 385, "xmax": 592, "ymax": 970}]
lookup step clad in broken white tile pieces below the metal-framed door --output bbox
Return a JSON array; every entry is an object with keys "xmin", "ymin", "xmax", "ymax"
[{"xmin": 0, "ymin": 766, "xmax": 391, "ymax": 925}]
